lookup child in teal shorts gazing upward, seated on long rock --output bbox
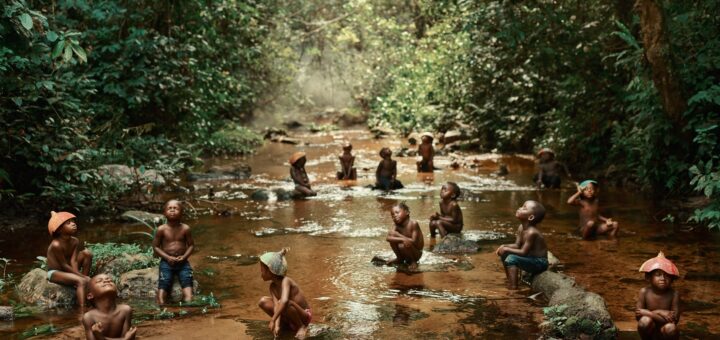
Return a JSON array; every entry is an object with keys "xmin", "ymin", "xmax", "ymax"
[{"xmin": 495, "ymin": 201, "xmax": 548, "ymax": 290}]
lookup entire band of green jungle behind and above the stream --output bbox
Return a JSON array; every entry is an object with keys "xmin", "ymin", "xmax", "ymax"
[{"xmin": 0, "ymin": 0, "xmax": 720, "ymax": 228}]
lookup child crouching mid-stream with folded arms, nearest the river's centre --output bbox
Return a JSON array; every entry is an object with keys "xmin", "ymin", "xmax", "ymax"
[{"xmin": 385, "ymin": 202, "xmax": 425, "ymax": 271}]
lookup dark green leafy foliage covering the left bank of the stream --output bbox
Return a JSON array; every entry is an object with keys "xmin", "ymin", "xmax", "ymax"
[{"xmin": 0, "ymin": 0, "xmax": 284, "ymax": 209}]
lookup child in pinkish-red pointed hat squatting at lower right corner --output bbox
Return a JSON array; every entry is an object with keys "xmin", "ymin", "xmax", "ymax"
[{"xmin": 635, "ymin": 252, "xmax": 680, "ymax": 339}]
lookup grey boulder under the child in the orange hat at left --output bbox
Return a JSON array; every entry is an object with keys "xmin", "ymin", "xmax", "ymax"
[{"xmin": 17, "ymin": 268, "xmax": 76, "ymax": 308}]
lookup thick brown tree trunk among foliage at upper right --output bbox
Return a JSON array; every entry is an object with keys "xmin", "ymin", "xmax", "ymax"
[{"xmin": 635, "ymin": 0, "xmax": 686, "ymax": 127}]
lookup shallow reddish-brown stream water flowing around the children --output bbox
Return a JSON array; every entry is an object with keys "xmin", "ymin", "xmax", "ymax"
[{"xmin": 0, "ymin": 131, "xmax": 720, "ymax": 339}]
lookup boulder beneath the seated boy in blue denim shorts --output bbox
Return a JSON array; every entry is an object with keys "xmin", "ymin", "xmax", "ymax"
[{"xmin": 118, "ymin": 267, "xmax": 198, "ymax": 299}]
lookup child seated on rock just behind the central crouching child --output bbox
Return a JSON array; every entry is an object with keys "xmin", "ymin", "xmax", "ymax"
[{"xmin": 430, "ymin": 182, "xmax": 463, "ymax": 237}]
